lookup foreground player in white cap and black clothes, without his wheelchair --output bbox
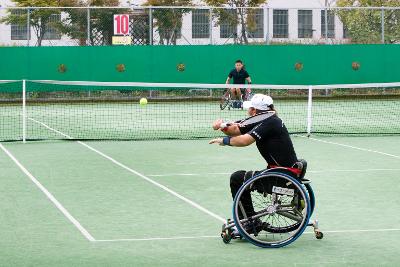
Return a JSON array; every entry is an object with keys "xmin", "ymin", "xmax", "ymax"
[{"xmin": 210, "ymin": 94, "xmax": 298, "ymax": 232}]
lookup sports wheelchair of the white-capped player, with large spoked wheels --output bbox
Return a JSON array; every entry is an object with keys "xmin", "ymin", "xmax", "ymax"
[{"xmin": 221, "ymin": 160, "xmax": 323, "ymax": 248}]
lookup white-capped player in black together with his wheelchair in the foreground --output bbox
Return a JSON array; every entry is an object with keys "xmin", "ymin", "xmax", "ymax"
[{"xmin": 209, "ymin": 94, "xmax": 322, "ymax": 247}]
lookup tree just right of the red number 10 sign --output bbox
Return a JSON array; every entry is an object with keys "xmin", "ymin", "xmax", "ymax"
[{"xmin": 145, "ymin": 0, "xmax": 192, "ymax": 45}]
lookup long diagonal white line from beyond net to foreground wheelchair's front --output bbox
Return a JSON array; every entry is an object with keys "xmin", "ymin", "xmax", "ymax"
[{"xmin": 28, "ymin": 118, "xmax": 226, "ymax": 225}]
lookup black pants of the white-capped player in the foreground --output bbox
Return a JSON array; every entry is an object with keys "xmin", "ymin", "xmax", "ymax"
[{"xmin": 230, "ymin": 170, "xmax": 260, "ymax": 219}]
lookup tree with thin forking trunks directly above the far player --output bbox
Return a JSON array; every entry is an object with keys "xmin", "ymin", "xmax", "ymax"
[{"xmin": 205, "ymin": 0, "xmax": 267, "ymax": 44}]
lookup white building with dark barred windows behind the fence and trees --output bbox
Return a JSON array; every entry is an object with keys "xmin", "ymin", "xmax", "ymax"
[{"xmin": 0, "ymin": 0, "xmax": 346, "ymax": 46}]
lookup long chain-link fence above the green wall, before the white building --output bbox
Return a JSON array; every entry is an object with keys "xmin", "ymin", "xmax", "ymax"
[{"xmin": 0, "ymin": 7, "xmax": 400, "ymax": 46}]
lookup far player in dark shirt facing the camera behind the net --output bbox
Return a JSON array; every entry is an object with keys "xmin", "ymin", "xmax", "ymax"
[{"xmin": 226, "ymin": 59, "xmax": 251, "ymax": 106}]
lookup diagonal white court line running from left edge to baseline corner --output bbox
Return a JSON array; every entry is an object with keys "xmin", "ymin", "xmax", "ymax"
[{"xmin": 0, "ymin": 143, "xmax": 95, "ymax": 242}]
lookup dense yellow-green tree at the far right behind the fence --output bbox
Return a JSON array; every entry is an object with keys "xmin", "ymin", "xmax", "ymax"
[{"xmin": 337, "ymin": 0, "xmax": 400, "ymax": 43}]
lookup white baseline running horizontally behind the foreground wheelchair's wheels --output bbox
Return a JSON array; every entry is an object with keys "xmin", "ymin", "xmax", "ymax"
[{"xmin": 96, "ymin": 228, "xmax": 400, "ymax": 242}]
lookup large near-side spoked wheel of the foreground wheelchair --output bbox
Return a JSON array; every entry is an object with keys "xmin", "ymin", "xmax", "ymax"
[{"xmin": 233, "ymin": 171, "xmax": 311, "ymax": 248}]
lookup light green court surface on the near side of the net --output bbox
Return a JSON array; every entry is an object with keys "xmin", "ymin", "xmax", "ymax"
[{"xmin": 0, "ymin": 136, "xmax": 400, "ymax": 266}]
